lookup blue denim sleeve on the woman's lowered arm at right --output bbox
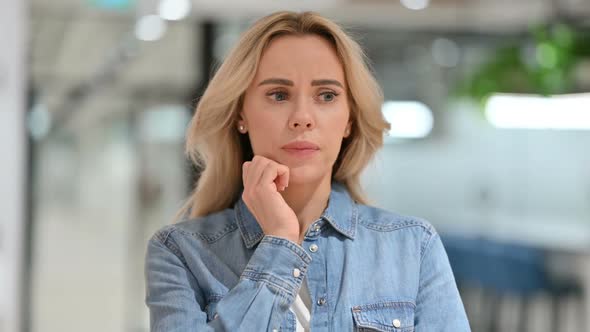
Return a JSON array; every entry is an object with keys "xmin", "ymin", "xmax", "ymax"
[{"xmin": 414, "ymin": 232, "xmax": 471, "ymax": 332}]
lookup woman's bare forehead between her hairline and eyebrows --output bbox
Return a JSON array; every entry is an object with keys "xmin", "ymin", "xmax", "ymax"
[{"xmin": 255, "ymin": 35, "xmax": 344, "ymax": 84}]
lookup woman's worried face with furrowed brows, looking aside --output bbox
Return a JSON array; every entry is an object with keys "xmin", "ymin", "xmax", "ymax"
[{"xmin": 239, "ymin": 35, "xmax": 350, "ymax": 184}]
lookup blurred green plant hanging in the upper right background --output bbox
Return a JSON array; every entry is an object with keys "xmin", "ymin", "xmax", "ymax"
[{"xmin": 455, "ymin": 23, "xmax": 590, "ymax": 109}]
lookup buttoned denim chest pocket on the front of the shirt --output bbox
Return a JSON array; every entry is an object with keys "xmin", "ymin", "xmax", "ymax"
[{"xmin": 352, "ymin": 302, "xmax": 416, "ymax": 332}]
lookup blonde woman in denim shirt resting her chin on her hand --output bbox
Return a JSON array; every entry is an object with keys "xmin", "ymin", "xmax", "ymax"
[{"xmin": 146, "ymin": 12, "xmax": 469, "ymax": 332}]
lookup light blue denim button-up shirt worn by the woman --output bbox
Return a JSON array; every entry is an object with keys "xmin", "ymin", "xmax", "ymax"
[{"xmin": 145, "ymin": 182, "xmax": 470, "ymax": 332}]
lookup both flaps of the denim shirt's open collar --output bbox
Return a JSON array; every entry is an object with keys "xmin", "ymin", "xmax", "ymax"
[{"xmin": 234, "ymin": 181, "xmax": 358, "ymax": 248}]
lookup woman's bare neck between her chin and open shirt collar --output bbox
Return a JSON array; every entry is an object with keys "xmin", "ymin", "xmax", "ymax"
[{"xmin": 281, "ymin": 176, "xmax": 331, "ymax": 243}]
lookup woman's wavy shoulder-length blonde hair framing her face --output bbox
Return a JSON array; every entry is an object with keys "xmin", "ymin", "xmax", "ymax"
[{"xmin": 175, "ymin": 11, "xmax": 389, "ymax": 220}]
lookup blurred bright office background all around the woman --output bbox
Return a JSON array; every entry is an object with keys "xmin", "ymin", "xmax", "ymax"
[{"xmin": 0, "ymin": 0, "xmax": 590, "ymax": 332}]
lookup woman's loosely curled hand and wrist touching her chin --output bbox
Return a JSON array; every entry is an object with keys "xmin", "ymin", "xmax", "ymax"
[{"xmin": 242, "ymin": 155, "xmax": 299, "ymax": 243}]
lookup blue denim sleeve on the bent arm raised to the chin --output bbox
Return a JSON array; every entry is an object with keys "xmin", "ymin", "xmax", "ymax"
[{"xmin": 145, "ymin": 235, "xmax": 311, "ymax": 332}]
